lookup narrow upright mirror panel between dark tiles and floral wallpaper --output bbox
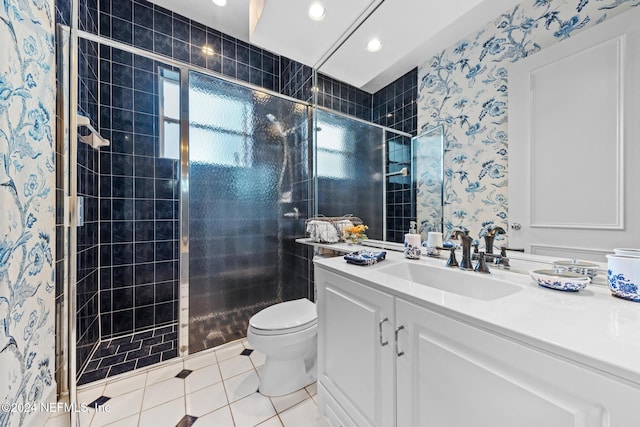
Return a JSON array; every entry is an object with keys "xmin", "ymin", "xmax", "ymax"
[{"xmin": 411, "ymin": 126, "xmax": 442, "ymax": 240}]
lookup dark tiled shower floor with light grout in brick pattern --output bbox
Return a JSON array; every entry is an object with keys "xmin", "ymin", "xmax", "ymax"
[{"xmin": 78, "ymin": 325, "xmax": 178, "ymax": 385}]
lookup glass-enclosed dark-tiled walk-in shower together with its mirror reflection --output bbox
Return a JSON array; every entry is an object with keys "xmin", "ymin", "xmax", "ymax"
[{"xmin": 61, "ymin": 33, "xmax": 408, "ymax": 392}]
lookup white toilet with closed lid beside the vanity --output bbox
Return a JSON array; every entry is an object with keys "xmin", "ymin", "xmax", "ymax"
[{"xmin": 247, "ymin": 298, "xmax": 318, "ymax": 396}]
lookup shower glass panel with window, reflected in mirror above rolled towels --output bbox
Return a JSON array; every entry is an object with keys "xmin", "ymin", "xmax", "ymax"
[{"xmin": 315, "ymin": 110, "xmax": 385, "ymax": 240}]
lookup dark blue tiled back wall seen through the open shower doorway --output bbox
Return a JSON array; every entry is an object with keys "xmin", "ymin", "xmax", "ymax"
[{"xmin": 100, "ymin": 45, "xmax": 179, "ymax": 342}]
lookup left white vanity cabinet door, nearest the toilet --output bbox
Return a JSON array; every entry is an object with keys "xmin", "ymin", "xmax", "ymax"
[{"xmin": 315, "ymin": 268, "xmax": 395, "ymax": 427}]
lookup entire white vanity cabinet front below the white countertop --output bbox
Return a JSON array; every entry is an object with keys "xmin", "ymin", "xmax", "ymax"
[{"xmin": 316, "ymin": 268, "xmax": 640, "ymax": 427}]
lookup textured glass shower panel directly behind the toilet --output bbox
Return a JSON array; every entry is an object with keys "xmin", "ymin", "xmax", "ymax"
[{"xmin": 189, "ymin": 72, "xmax": 309, "ymax": 353}]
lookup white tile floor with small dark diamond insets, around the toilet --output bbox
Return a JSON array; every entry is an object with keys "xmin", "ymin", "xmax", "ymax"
[{"xmin": 45, "ymin": 340, "xmax": 328, "ymax": 427}]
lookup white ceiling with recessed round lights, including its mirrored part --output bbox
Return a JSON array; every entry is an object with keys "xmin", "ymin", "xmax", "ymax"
[{"xmin": 151, "ymin": 0, "xmax": 521, "ymax": 93}]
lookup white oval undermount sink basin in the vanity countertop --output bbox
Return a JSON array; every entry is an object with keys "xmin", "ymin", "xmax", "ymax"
[{"xmin": 378, "ymin": 262, "xmax": 522, "ymax": 301}]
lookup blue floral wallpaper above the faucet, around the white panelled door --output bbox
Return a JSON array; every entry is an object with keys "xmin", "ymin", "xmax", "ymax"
[{"xmin": 418, "ymin": 0, "xmax": 640, "ymax": 244}]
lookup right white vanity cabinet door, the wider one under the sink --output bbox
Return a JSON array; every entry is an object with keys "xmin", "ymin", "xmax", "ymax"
[{"xmin": 396, "ymin": 299, "xmax": 640, "ymax": 427}]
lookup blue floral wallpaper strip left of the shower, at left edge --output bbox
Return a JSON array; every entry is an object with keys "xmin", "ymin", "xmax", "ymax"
[{"xmin": 0, "ymin": 0, "xmax": 55, "ymax": 426}]
